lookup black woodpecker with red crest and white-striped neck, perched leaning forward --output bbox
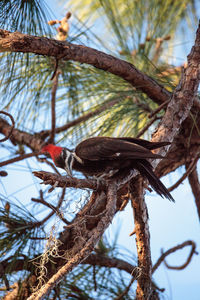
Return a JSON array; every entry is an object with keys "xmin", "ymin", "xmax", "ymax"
[{"xmin": 41, "ymin": 137, "xmax": 174, "ymax": 201}]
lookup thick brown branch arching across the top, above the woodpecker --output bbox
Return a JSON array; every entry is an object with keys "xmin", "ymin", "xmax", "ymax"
[{"xmin": 0, "ymin": 29, "xmax": 170, "ymax": 105}]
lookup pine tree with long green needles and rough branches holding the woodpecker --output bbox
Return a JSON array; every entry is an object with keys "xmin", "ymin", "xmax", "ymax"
[{"xmin": 0, "ymin": 0, "xmax": 200, "ymax": 299}]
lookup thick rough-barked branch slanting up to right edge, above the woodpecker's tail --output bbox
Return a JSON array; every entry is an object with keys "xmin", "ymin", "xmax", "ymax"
[{"xmin": 152, "ymin": 25, "xmax": 200, "ymax": 155}]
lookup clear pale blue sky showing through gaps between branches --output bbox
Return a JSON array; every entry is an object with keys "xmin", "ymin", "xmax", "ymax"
[{"xmin": 0, "ymin": 0, "xmax": 200, "ymax": 300}]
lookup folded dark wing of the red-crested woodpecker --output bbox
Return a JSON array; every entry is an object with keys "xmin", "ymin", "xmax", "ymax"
[{"xmin": 75, "ymin": 137, "xmax": 162, "ymax": 160}]
